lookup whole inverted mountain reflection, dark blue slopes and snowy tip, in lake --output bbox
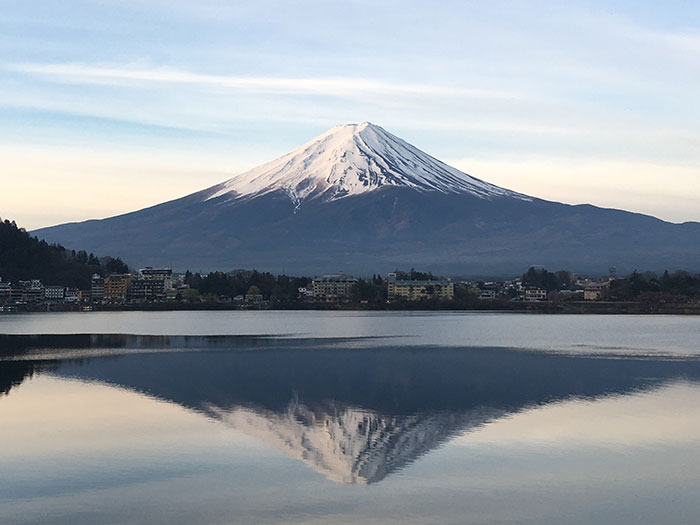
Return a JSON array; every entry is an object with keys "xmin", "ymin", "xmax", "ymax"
[{"xmin": 0, "ymin": 338, "xmax": 700, "ymax": 483}]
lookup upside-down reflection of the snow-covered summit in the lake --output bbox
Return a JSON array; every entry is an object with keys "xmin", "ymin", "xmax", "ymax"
[{"xmin": 208, "ymin": 403, "xmax": 500, "ymax": 484}]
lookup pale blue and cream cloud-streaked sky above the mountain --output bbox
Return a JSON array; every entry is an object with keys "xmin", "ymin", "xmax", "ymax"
[{"xmin": 0, "ymin": 0, "xmax": 700, "ymax": 230}]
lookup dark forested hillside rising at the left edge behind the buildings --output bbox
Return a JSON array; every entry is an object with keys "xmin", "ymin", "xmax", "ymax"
[{"xmin": 0, "ymin": 216, "xmax": 128, "ymax": 288}]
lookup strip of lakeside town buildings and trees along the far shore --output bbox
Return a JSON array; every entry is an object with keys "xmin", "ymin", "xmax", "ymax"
[{"xmin": 0, "ymin": 267, "xmax": 700, "ymax": 313}]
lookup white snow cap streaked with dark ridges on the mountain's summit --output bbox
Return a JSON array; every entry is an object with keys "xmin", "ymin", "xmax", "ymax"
[{"xmin": 209, "ymin": 122, "xmax": 529, "ymax": 207}]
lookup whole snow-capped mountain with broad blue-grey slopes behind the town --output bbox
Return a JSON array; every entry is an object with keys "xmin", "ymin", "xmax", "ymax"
[{"xmin": 34, "ymin": 122, "xmax": 700, "ymax": 276}]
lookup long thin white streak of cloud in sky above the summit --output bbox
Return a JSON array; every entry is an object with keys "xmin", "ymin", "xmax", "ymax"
[{"xmin": 4, "ymin": 63, "xmax": 520, "ymax": 100}]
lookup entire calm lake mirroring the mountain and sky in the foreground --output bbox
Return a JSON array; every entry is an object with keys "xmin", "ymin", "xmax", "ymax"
[{"xmin": 0, "ymin": 311, "xmax": 700, "ymax": 524}]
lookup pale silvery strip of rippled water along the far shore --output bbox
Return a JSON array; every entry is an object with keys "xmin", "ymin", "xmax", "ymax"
[{"xmin": 0, "ymin": 310, "xmax": 700, "ymax": 356}]
